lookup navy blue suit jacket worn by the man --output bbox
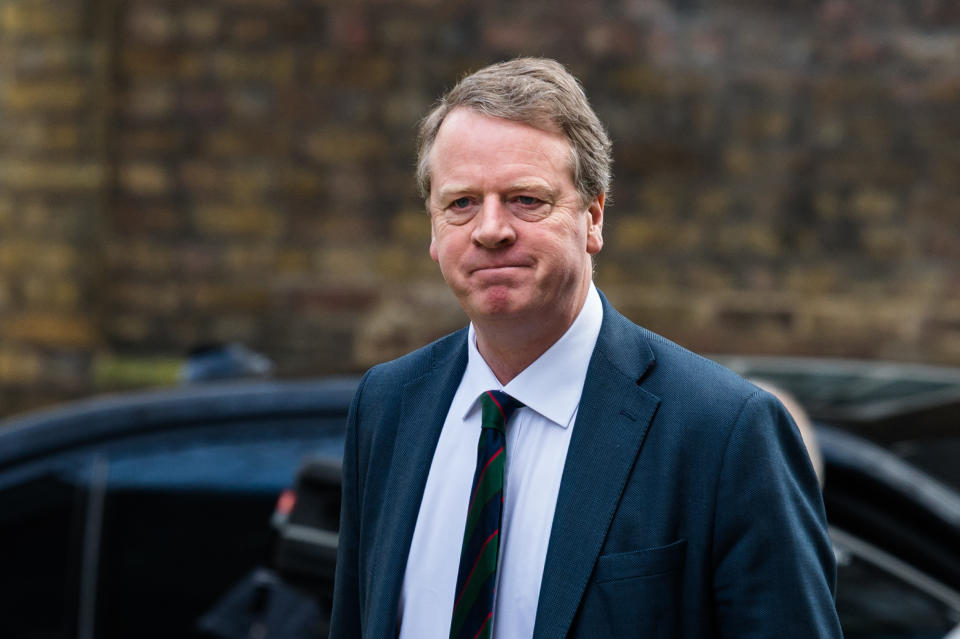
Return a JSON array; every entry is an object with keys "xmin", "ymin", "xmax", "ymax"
[{"xmin": 330, "ymin": 299, "xmax": 841, "ymax": 639}]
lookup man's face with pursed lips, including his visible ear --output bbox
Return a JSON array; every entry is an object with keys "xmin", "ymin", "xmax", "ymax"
[{"xmin": 428, "ymin": 108, "xmax": 603, "ymax": 322}]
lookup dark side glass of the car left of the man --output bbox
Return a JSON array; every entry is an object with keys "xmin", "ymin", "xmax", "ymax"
[{"xmin": 0, "ymin": 415, "xmax": 344, "ymax": 639}]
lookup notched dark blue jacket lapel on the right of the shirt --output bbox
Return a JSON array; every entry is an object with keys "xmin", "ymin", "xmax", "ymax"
[{"xmin": 534, "ymin": 299, "xmax": 659, "ymax": 639}]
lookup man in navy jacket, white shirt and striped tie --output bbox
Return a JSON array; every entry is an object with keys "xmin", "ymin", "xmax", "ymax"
[{"xmin": 331, "ymin": 59, "xmax": 840, "ymax": 639}]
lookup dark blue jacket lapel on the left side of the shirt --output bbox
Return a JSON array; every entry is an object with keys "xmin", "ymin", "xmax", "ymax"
[{"xmin": 370, "ymin": 330, "xmax": 467, "ymax": 637}]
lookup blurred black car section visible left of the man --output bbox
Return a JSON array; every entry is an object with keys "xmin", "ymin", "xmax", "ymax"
[{"xmin": 0, "ymin": 380, "xmax": 356, "ymax": 639}]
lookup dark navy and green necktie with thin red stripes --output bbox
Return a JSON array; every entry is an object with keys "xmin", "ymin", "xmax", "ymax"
[{"xmin": 450, "ymin": 391, "xmax": 523, "ymax": 639}]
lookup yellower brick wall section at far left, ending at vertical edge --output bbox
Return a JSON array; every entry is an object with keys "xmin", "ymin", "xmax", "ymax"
[{"xmin": 0, "ymin": 0, "xmax": 110, "ymax": 412}]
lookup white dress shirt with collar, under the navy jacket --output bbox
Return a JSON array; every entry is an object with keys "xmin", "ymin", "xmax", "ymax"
[{"xmin": 399, "ymin": 283, "xmax": 603, "ymax": 639}]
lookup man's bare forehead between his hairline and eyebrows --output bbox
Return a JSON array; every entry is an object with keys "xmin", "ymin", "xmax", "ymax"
[{"xmin": 430, "ymin": 107, "xmax": 573, "ymax": 187}]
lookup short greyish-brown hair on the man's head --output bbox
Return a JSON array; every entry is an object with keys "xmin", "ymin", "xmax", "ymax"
[{"xmin": 417, "ymin": 58, "xmax": 613, "ymax": 202}]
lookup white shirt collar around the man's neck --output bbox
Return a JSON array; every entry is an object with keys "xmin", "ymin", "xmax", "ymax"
[{"xmin": 460, "ymin": 282, "xmax": 603, "ymax": 428}]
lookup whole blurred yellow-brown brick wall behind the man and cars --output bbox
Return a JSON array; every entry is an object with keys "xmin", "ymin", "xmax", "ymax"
[{"xmin": 0, "ymin": 0, "xmax": 960, "ymax": 415}]
